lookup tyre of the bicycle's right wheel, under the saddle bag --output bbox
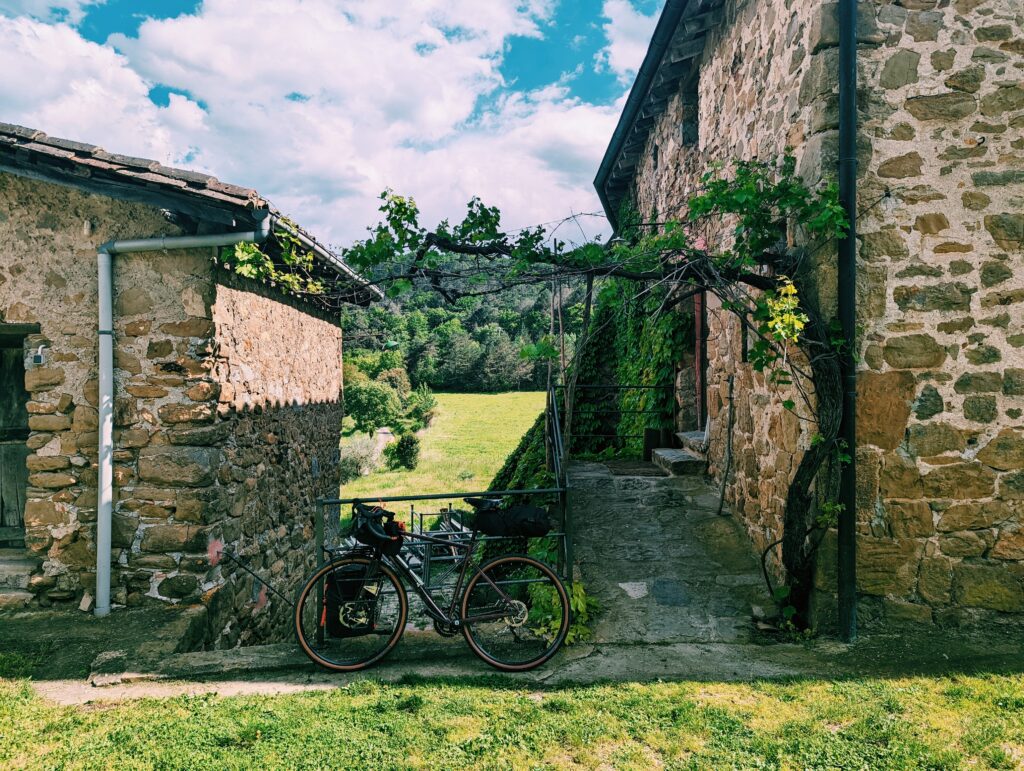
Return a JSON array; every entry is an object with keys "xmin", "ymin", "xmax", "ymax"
[{"xmin": 460, "ymin": 555, "xmax": 571, "ymax": 672}]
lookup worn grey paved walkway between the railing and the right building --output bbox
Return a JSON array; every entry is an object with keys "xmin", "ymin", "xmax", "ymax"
[{"xmin": 568, "ymin": 463, "xmax": 771, "ymax": 644}]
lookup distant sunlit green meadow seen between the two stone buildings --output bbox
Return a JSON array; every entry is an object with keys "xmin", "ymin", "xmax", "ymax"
[{"xmin": 341, "ymin": 391, "xmax": 544, "ymax": 498}]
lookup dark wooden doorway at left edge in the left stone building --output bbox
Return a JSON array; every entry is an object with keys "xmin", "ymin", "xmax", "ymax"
[{"xmin": 0, "ymin": 324, "xmax": 39, "ymax": 549}]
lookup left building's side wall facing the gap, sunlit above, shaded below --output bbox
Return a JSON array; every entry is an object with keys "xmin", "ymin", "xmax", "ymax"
[{"xmin": 208, "ymin": 285, "xmax": 342, "ymax": 647}]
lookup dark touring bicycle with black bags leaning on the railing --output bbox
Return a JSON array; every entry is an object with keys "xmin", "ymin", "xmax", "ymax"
[{"xmin": 295, "ymin": 498, "xmax": 570, "ymax": 672}]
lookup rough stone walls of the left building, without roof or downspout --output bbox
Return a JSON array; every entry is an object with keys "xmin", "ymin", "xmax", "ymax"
[{"xmin": 0, "ymin": 173, "xmax": 341, "ymax": 645}]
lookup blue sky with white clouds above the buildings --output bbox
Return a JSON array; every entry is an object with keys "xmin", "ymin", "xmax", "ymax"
[{"xmin": 0, "ymin": 0, "xmax": 662, "ymax": 245}]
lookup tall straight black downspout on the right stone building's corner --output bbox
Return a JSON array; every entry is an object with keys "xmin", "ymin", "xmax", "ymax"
[{"xmin": 838, "ymin": 0, "xmax": 857, "ymax": 642}]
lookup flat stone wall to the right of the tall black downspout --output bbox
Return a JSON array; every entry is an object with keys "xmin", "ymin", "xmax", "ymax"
[{"xmin": 821, "ymin": 0, "xmax": 1024, "ymax": 624}]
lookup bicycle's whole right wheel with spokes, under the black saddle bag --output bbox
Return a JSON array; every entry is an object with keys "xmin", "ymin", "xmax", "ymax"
[{"xmin": 462, "ymin": 556, "xmax": 570, "ymax": 672}]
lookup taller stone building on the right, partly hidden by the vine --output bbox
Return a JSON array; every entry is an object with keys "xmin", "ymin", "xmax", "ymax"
[{"xmin": 596, "ymin": 0, "xmax": 1024, "ymax": 625}]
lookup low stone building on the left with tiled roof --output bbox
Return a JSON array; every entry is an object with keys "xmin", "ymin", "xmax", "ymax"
[{"xmin": 0, "ymin": 124, "xmax": 379, "ymax": 645}]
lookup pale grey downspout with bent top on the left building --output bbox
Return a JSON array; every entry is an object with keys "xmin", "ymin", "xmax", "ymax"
[{"xmin": 94, "ymin": 216, "xmax": 272, "ymax": 616}]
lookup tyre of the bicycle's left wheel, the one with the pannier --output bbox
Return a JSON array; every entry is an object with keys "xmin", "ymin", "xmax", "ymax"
[{"xmin": 294, "ymin": 557, "xmax": 409, "ymax": 672}]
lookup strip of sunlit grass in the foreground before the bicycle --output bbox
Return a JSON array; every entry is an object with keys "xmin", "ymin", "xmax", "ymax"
[{"xmin": 0, "ymin": 675, "xmax": 1024, "ymax": 770}]
